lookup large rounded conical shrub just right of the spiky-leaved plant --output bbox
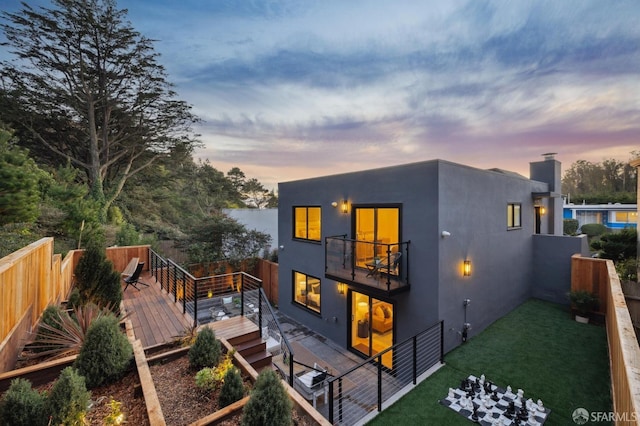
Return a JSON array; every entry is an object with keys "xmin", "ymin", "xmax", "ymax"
[{"xmin": 74, "ymin": 315, "xmax": 133, "ymax": 389}]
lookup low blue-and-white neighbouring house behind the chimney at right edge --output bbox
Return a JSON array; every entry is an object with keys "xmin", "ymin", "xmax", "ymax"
[{"xmin": 563, "ymin": 203, "xmax": 638, "ymax": 229}]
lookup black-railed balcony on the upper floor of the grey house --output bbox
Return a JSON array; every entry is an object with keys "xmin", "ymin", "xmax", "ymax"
[{"xmin": 324, "ymin": 235, "xmax": 410, "ymax": 295}]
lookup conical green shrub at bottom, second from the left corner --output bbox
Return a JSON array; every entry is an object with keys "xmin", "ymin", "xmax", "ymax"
[{"xmin": 45, "ymin": 367, "xmax": 91, "ymax": 425}]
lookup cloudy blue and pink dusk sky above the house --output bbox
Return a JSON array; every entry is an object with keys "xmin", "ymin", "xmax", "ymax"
[{"xmin": 0, "ymin": 0, "xmax": 640, "ymax": 188}]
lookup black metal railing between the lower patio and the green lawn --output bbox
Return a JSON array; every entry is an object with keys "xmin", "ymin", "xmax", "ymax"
[{"xmin": 328, "ymin": 321, "xmax": 444, "ymax": 425}]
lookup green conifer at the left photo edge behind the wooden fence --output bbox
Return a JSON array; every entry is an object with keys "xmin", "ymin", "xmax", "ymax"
[{"xmin": 0, "ymin": 128, "xmax": 47, "ymax": 225}]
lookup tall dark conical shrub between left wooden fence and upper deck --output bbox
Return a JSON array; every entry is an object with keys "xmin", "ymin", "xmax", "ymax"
[{"xmin": 75, "ymin": 244, "xmax": 122, "ymax": 312}]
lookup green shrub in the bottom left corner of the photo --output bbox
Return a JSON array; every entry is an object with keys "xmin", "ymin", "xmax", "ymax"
[{"xmin": 0, "ymin": 379, "xmax": 47, "ymax": 426}]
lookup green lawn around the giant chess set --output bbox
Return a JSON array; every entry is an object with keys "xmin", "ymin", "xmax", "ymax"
[{"xmin": 368, "ymin": 299, "xmax": 612, "ymax": 426}]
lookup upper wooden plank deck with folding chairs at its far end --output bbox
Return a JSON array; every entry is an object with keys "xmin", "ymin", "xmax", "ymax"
[{"xmin": 122, "ymin": 271, "xmax": 192, "ymax": 348}]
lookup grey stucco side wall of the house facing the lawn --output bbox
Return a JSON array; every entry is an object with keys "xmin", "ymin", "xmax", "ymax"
[{"xmin": 438, "ymin": 162, "xmax": 548, "ymax": 351}]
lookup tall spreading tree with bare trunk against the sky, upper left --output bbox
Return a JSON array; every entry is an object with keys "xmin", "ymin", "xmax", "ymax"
[{"xmin": 0, "ymin": 0, "xmax": 196, "ymax": 220}]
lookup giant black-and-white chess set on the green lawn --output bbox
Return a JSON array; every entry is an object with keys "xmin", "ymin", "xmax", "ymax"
[{"xmin": 440, "ymin": 375, "xmax": 551, "ymax": 426}]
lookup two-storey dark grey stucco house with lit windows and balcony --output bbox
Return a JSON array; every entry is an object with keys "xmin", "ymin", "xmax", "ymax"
[{"xmin": 278, "ymin": 156, "xmax": 589, "ymax": 367}]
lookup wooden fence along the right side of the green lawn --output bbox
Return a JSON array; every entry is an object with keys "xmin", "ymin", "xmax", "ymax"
[{"xmin": 571, "ymin": 255, "xmax": 640, "ymax": 425}]
